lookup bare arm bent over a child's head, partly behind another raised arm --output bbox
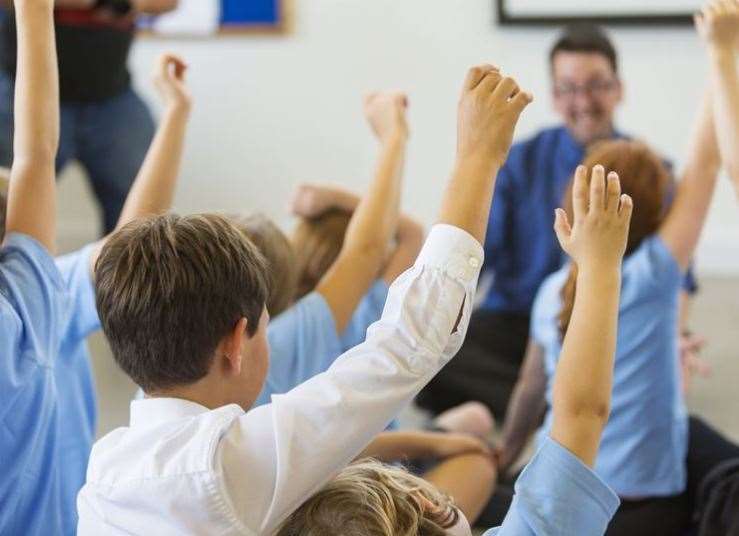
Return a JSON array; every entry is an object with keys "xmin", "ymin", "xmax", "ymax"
[{"xmin": 292, "ymin": 184, "xmax": 424, "ymax": 285}]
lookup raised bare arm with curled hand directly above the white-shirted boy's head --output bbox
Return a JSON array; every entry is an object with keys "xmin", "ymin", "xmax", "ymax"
[{"xmin": 90, "ymin": 54, "xmax": 192, "ymax": 269}]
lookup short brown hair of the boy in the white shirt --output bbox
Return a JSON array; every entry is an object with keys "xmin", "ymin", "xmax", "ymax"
[{"xmin": 95, "ymin": 214, "xmax": 268, "ymax": 392}]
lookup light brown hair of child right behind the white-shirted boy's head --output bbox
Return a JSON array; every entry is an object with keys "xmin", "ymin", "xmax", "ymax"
[{"xmin": 230, "ymin": 214, "xmax": 298, "ymax": 316}]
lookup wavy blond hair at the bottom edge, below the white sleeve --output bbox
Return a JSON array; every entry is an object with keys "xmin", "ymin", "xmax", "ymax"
[{"xmin": 276, "ymin": 460, "xmax": 460, "ymax": 536}]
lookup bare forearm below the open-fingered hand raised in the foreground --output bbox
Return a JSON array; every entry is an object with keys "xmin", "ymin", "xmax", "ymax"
[{"xmin": 551, "ymin": 266, "xmax": 621, "ymax": 465}]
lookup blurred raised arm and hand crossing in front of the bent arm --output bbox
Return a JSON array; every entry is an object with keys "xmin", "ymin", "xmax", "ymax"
[{"xmin": 316, "ymin": 94, "xmax": 408, "ymax": 333}]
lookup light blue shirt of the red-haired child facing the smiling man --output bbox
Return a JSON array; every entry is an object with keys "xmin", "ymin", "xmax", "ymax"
[{"xmin": 531, "ymin": 235, "xmax": 688, "ymax": 498}]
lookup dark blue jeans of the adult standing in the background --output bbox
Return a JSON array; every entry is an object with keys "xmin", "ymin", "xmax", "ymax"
[{"xmin": 0, "ymin": 74, "xmax": 155, "ymax": 233}]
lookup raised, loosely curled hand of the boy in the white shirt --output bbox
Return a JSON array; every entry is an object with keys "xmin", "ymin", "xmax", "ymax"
[{"xmin": 457, "ymin": 65, "xmax": 533, "ymax": 165}]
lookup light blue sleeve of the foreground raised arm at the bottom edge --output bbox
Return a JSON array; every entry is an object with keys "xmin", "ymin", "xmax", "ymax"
[{"xmin": 484, "ymin": 438, "xmax": 619, "ymax": 536}]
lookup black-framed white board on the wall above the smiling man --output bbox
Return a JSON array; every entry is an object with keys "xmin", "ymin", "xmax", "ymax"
[{"xmin": 495, "ymin": 0, "xmax": 703, "ymax": 25}]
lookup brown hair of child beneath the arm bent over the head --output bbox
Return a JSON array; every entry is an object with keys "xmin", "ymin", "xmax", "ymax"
[{"xmin": 292, "ymin": 209, "xmax": 352, "ymax": 298}]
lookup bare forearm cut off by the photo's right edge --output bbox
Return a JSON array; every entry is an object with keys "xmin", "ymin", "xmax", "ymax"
[{"xmin": 709, "ymin": 47, "xmax": 739, "ymax": 195}]
